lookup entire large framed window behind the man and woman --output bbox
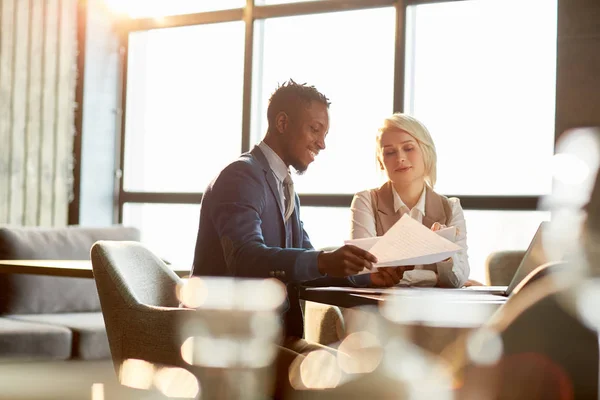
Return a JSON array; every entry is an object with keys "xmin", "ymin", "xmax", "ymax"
[{"xmin": 119, "ymin": 0, "xmax": 557, "ymax": 280}]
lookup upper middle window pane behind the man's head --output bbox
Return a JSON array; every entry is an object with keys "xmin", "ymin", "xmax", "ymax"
[{"xmin": 252, "ymin": 7, "xmax": 396, "ymax": 193}]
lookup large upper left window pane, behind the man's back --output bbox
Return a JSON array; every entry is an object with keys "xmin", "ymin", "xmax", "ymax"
[{"xmin": 123, "ymin": 22, "xmax": 244, "ymax": 192}]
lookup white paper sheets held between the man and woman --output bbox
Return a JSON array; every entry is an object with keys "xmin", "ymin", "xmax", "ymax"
[{"xmin": 345, "ymin": 214, "xmax": 461, "ymax": 274}]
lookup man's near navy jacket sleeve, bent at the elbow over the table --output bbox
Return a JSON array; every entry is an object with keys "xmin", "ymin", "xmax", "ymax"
[{"xmin": 211, "ymin": 161, "xmax": 322, "ymax": 283}]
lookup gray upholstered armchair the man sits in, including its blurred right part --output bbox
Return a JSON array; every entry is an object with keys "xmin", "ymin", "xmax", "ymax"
[{"xmin": 91, "ymin": 241, "xmax": 277, "ymax": 398}]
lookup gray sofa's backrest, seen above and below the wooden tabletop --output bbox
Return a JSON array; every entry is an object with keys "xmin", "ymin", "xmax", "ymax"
[{"xmin": 0, "ymin": 226, "xmax": 140, "ymax": 314}]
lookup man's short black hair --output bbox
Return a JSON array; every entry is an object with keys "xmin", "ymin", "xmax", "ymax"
[{"xmin": 267, "ymin": 79, "xmax": 331, "ymax": 127}]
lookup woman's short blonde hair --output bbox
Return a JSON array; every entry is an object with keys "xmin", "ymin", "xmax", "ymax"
[{"xmin": 376, "ymin": 113, "xmax": 437, "ymax": 189}]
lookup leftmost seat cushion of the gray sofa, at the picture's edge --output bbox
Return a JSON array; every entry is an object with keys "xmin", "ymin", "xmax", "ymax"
[{"xmin": 0, "ymin": 318, "xmax": 72, "ymax": 361}]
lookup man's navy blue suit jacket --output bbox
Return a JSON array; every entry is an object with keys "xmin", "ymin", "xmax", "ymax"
[{"xmin": 192, "ymin": 147, "xmax": 332, "ymax": 338}]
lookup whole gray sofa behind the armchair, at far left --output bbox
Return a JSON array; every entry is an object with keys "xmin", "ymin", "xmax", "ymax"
[{"xmin": 0, "ymin": 226, "xmax": 140, "ymax": 361}]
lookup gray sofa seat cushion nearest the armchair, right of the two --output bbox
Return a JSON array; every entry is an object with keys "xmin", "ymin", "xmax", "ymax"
[{"xmin": 7, "ymin": 312, "xmax": 110, "ymax": 360}]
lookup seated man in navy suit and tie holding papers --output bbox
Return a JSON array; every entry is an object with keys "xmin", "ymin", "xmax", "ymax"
[{"xmin": 192, "ymin": 80, "xmax": 401, "ymax": 366}]
